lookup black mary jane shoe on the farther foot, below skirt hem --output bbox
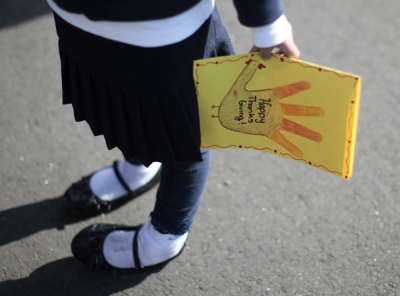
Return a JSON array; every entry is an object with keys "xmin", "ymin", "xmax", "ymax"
[{"xmin": 63, "ymin": 161, "xmax": 161, "ymax": 217}]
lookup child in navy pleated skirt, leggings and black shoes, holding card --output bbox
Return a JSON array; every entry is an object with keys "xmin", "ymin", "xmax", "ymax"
[{"xmin": 48, "ymin": 0, "xmax": 299, "ymax": 269}]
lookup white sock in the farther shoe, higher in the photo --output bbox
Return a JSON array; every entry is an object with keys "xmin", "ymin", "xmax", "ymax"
[{"xmin": 90, "ymin": 160, "xmax": 161, "ymax": 201}]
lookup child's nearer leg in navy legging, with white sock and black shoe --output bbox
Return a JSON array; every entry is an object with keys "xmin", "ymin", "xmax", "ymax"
[{"xmin": 72, "ymin": 151, "xmax": 210, "ymax": 268}]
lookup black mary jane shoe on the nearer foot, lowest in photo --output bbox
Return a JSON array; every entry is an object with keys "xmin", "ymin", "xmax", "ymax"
[{"xmin": 71, "ymin": 223, "xmax": 184, "ymax": 270}]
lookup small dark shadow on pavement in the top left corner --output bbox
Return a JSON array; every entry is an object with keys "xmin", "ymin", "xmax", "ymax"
[{"xmin": 0, "ymin": 0, "xmax": 51, "ymax": 29}]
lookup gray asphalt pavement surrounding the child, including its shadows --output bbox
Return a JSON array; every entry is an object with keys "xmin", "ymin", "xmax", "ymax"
[{"xmin": 0, "ymin": 0, "xmax": 400, "ymax": 295}]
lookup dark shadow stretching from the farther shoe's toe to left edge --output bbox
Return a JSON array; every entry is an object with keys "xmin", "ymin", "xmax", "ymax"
[{"xmin": 0, "ymin": 197, "xmax": 84, "ymax": 246}]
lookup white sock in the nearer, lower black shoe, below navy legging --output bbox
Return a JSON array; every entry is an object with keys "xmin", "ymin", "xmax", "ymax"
[{"xmin": 103, "ymin": 221, "xmax": 188, "ymax": 268}]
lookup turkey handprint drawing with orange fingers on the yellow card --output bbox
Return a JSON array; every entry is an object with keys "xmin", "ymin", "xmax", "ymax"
[{"xmin": 214, "ymin": 61, "xmax": 324, "ymax": 157}]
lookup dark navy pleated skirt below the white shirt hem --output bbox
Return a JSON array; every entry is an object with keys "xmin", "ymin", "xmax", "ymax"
[{"xmin": 55, "ymin": 10, "xmax": 233, "ymax": 166}]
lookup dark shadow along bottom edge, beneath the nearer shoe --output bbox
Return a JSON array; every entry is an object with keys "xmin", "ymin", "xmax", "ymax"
[{"xmin": 0, "ymin": 257, "xmax": 165, "ymax": 296}]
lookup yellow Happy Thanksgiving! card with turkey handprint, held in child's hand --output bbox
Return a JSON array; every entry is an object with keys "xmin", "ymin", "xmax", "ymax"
[{"xmin": 193, "ymin": 53, "xmax": 361, "ymax": 179}]
